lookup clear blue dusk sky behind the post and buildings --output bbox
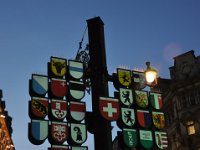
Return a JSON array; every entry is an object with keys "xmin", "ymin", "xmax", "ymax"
[{"xmin": 0, "ymin": 0, "xmax": 200, "ymax": 150}]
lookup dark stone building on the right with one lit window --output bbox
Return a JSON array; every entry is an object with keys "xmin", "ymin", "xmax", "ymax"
[{"xmin": 153, "ymin": 50, "xmax": 200, "ymax": 150}]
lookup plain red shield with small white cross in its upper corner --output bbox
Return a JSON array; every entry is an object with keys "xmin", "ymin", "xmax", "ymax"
[{"xmin": 50, "ymin": 78, "xmax": 68, "ymax": 98}]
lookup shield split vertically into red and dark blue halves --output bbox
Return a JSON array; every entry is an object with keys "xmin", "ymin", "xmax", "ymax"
[{"xmin": 137, "ymin": 110, "xmax": 151, "ymax": 128}]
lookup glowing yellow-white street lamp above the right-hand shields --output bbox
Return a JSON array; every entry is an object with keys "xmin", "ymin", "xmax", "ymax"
[{"xmin": 144, "ymin": 62, "xmax": 158, "ymax": 86}]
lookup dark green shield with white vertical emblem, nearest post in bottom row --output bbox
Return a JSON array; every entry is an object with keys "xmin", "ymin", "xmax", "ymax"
[{"xmin": 122, "ymin": 128, "xmax": 138, "ymax": 148}]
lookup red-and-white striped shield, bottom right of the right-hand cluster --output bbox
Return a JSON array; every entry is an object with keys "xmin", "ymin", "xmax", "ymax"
[{"xmin": 155, "ymin": 131, "xmax": 168, "ymax": 149}]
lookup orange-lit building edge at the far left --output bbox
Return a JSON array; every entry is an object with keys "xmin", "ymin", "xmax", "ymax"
[{"xmin": 0, "ymin": 90, "xmax": 15, "ymax": 150}]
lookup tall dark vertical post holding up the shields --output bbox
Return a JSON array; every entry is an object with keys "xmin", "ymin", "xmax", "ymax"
[{"xmin": 87, "ymin": 17, "xmax": 112, "ymax": 150}]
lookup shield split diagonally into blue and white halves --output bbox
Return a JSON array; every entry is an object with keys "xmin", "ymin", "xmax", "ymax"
[{"xmin": 30, "ymin": 74, "xmax": 48, "ymax": 97}]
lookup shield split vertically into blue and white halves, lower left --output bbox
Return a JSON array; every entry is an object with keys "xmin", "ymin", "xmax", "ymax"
[{"xmin": 28, "ymin": 120, "xmax": 48, "ymax": 145}]
